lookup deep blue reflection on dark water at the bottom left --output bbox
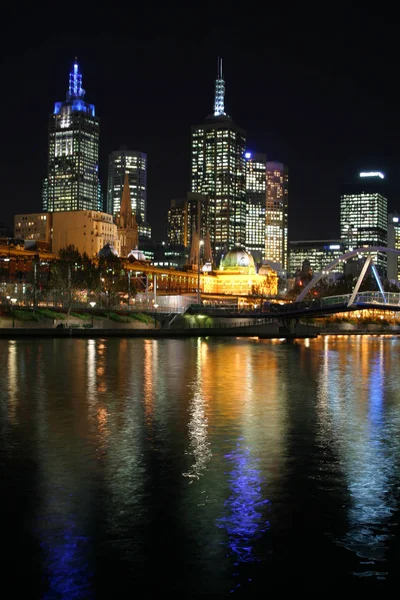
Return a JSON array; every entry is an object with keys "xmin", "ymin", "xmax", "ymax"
[{"xmin": 41, "ymin": 522, "xmax": 92, "ymax": 600}]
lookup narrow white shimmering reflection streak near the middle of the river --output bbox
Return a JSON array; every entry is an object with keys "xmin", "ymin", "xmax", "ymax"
[{"xmin": 183, "ymin": 338, "xmax": 212, "ymax": 483}]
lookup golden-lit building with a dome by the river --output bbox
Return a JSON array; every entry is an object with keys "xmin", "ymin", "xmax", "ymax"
[{"xmin": 201, "ymin": 248, "xmax": 278, "ymax": 296}]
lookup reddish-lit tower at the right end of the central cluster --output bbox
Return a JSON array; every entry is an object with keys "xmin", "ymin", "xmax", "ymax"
[{"xmin": 265, "ymin": 161, "xmax": 289, "ymax": 271}]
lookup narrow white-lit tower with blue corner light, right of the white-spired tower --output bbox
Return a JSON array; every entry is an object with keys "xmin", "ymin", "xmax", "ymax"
[{"xmin": 245, "ymin": 152, "xmax": 267, "ymax": 262}]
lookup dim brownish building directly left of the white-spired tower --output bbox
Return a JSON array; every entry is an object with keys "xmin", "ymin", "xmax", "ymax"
[{"xmin": 167, "ymin": 192, "xmax": 209, "ymax": 247}]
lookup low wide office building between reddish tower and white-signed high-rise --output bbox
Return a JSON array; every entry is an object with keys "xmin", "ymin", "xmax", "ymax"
[{"xmin": 289, "ymin": 240, "xmax": 345, "ymax": 277}]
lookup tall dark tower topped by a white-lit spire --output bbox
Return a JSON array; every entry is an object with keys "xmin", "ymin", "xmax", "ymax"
[{"xmin": 192, "ymin": 60, "xmax": 246, "ymax": 254}]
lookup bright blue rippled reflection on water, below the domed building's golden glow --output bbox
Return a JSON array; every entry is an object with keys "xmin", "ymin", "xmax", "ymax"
[{"xmin": 217, "ymin": 439, "xmax": 269, "ymax": 562}]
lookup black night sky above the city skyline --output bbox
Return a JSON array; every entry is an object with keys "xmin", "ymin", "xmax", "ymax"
[{"xmin": 0, "ymin": 7, "xmax": 400, "ymax": 240}]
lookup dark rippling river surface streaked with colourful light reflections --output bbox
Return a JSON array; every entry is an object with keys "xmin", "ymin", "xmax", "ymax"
[{"xmin": 0, "ymin": 336, "xmax": 400, "ymax": 600}]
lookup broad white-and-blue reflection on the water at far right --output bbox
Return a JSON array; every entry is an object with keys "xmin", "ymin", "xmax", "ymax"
[{"xmin": 319, "ymin": 338, "xmax": 399, "ymax": 577}]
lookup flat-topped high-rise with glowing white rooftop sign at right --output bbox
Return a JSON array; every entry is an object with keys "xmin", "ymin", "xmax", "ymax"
[{"xmin": 340, "ymin": 171, "xmax": 388, "ymax": 274}]
